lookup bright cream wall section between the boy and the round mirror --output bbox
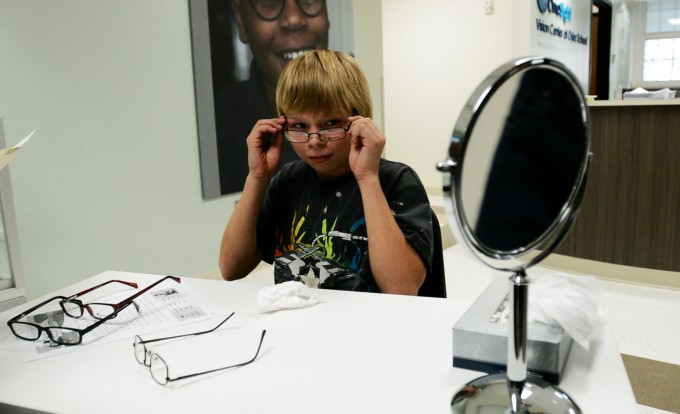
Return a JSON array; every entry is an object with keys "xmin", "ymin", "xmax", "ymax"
[{"xmin": 382, "ymin": 0, "xmax": 513, "ymax": 189}]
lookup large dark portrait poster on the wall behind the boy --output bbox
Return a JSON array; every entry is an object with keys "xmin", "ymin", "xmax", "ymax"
[{"xmin": 189, "ymin": 0, "xmax": 354, "ymax": 199}]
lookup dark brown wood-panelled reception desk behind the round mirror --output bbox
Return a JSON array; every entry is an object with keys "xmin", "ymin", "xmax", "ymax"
[{"xmin": 558, "ymin": 99, "xmax": 680, "ymax": 274}]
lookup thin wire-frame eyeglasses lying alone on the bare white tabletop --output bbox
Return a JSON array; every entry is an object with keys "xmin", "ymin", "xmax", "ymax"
[{"xmin": 133, "ymin": 312, "xmax": 267, "ymax": 385}]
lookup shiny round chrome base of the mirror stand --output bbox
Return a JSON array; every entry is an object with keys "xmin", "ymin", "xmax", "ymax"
[{"xmin": 451, "ymin": 374, "xmax": 581, "ymax": 414}]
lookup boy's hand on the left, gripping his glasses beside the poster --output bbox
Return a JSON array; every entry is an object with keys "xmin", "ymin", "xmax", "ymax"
[{"xmin": 247, "ymin": 116, "xmax": 286, "ymax": 179}]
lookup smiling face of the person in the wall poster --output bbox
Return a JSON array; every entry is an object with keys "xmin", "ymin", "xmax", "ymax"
[{"xmin": 234, "ymin": 0, "xmax": 330, "ymax": 92}]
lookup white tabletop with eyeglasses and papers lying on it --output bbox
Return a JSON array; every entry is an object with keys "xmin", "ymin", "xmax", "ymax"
[{"xmin": 0, "ymin": 266, "xmax": 635, "ymax": 413}]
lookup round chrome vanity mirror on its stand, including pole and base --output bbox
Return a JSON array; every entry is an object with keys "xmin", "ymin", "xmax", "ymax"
[{"xmin": 437, "ymin": 57, "xmax": 590, "ymax": 413}]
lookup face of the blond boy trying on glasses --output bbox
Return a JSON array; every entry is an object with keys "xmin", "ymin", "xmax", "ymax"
[{"xmin": 286, "ymin": 113, "xmax": 351, "ymax": 179}]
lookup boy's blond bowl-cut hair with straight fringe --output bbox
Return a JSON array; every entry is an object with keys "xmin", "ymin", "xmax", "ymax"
[{"xmin": 276, "ymin": 49, "xmax": 373, "ymax": 118}]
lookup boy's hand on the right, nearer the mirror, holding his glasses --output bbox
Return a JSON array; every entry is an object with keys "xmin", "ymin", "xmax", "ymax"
[{"xmin": 348, "ymin": 116, "xmax": 386, "ymax": 181}]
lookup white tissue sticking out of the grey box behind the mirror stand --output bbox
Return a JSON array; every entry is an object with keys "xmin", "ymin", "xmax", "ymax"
[{"xmin": 528, "ymin": 273, "xmax": 600, "ymax": 350}]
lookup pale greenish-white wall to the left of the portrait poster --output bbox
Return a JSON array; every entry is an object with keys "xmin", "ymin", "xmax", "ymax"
[{"xmin": 0, "ymin": 0, "xmax": 239, "ymax": 298}]
